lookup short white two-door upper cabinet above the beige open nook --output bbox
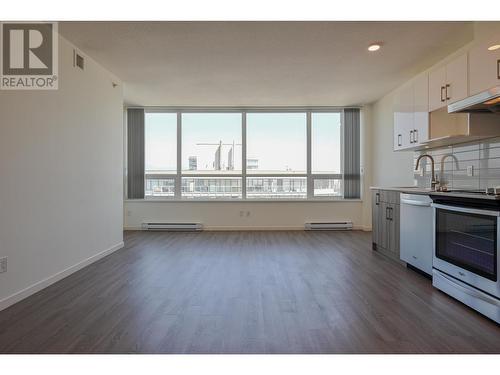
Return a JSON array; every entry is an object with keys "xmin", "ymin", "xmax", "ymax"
[{"xmin": 429, "ymin": 54, "xmax": 468, "ymax": 112}]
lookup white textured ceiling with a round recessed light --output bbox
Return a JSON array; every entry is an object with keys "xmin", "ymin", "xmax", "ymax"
[{"xmin": 59, "ymin": 22, "xmax": 473, "ymax": 106}]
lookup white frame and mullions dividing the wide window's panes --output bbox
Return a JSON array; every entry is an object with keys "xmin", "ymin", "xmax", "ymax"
[{"xmin": 139, "ymin": 107, "xmax": 356, "ymax": 202}]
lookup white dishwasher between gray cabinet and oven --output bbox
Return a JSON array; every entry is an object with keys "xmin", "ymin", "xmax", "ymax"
[{"xmin": 400, "ymin": 193, "xmax": 434, "ymax": 275}]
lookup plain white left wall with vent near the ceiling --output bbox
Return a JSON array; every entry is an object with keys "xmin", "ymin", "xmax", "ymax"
[{"xmin": 0, "ymin": 38, "xmax": 123, "ymax": 310}]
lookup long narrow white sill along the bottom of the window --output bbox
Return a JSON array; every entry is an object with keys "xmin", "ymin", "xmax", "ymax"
[{"xmin": 125, "ymin": 198, "xmax": 363, "ymax": 204}]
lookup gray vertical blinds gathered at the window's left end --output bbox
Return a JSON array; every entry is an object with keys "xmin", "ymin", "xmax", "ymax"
[{"xmin": 127, "ymin": 108, "xmax": 144, "ymax": 199}]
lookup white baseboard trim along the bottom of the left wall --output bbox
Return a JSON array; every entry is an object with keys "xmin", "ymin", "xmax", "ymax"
[{"xmin": 0, "ymin": 241, "xmax": 124, "ymax": 311}]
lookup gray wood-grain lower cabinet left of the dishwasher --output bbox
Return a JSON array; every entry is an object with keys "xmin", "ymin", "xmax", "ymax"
[{"xmin": 372, "ymin": 190, "xmax": 399, "ymax": 261}]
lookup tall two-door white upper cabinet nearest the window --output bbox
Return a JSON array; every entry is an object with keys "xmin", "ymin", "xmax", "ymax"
[{"xmin": 394, "ymin": 74, "xmax": 429, "ymax": 151}]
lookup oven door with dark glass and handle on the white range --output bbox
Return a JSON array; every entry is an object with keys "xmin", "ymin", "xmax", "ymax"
[{"xmin": 432, "ymin": 204, "xmax": 500, "ymax": 298}]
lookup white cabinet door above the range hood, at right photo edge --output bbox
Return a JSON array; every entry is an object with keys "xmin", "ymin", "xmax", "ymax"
[{"xmin": 469, "ymin": 35, "xmax": 500, "ymax": 95}]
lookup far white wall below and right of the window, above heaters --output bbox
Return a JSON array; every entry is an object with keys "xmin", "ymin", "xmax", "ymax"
[{"xmin": 124, "ymin": 106, "xmax": 371, "ymax": 230}]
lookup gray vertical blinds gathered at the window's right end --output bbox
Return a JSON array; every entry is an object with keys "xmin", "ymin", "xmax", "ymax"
[{"xmin": 344, "ymin": 108, "xmax": 361, "ymax": 199}]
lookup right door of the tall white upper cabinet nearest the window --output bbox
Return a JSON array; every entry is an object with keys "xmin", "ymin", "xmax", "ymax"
[{"xmin": 413, "ymin": 74, "xmax": 429, "ymax": 144}]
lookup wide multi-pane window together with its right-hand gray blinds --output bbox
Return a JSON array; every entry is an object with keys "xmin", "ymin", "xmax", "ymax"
[{"xmin": 137, "ymin": 108, "xmax": 360, "ymax": 200}]
